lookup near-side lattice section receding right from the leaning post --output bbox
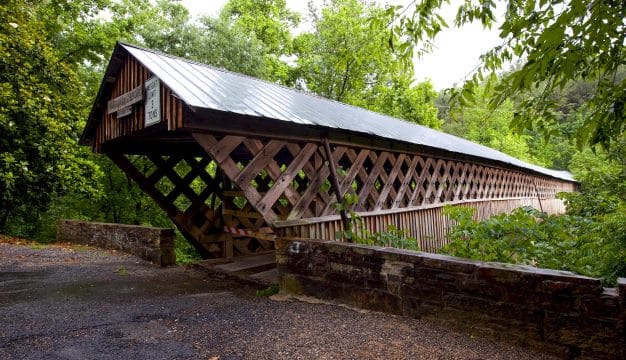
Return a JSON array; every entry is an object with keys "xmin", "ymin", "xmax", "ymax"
[{"xmin": 327, "ymin": 146, "xmax": 562, "ymax": 212}]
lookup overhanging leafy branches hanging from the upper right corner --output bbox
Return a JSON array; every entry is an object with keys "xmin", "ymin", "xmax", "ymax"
[{"xmin": 390, "ymin": 0, "xmax": 626, "ymax": 147}]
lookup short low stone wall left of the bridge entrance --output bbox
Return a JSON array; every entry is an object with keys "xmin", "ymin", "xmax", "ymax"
[{"xmin": 57, "ymin": 220, "xmax": 176, "ymax": 266}]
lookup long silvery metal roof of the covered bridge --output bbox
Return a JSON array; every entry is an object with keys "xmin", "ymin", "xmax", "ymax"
[{"xmin": 118, "ymin": 44, "xmax": 574, "ymax": 181}]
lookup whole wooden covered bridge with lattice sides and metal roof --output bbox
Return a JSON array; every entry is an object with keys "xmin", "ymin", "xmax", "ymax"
[{"xmin": 81, "ymin": 43, "xmax": 576, "ymax": 257}]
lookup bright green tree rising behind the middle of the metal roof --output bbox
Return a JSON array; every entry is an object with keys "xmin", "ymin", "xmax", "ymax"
[{"xmin": 292, "ymin": 0, "xmax": 440, "ymax": 127}]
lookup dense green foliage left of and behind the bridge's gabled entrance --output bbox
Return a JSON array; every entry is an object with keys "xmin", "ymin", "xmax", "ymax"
[{"xmin": 0, "ymin": 0, "xmax": 278, "ymax": 262}]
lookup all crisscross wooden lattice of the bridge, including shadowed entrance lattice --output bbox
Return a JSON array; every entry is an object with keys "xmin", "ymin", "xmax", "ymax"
[{"xmin": 108, "ymin": 132, "xmax": 573, "ymax": 257}]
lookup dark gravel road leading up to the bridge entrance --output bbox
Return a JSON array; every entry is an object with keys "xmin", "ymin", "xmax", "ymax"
[{"xmin": 0, "ymin": 243, "xmax": 550, "ymax": 360}]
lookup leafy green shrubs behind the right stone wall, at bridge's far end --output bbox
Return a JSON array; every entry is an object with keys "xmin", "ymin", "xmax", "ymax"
[{"xmin": 442, "ymin": 118, "xmax": 626, "ymax": 284}]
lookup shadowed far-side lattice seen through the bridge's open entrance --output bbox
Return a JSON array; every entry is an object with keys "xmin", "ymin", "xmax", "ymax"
[{"xmin": 109, "ymin": 154, "xmax": 273, "ymax": 257}]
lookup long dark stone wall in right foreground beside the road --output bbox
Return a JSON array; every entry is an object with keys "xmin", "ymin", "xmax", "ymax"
[{"xmin": 276, "ymin": 239, "xmax": 626, "ymax": 359}]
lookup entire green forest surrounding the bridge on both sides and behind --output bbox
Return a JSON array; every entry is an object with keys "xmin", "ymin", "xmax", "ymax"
[{"xmin": 0, "ymin": 0, "xmax": 626, "ymax": 282}]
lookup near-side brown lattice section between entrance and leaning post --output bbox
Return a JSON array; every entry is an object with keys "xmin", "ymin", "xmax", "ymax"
[{"xmin": 194, "ymin": 134, "xmax": 341, "ymax": 223}]
